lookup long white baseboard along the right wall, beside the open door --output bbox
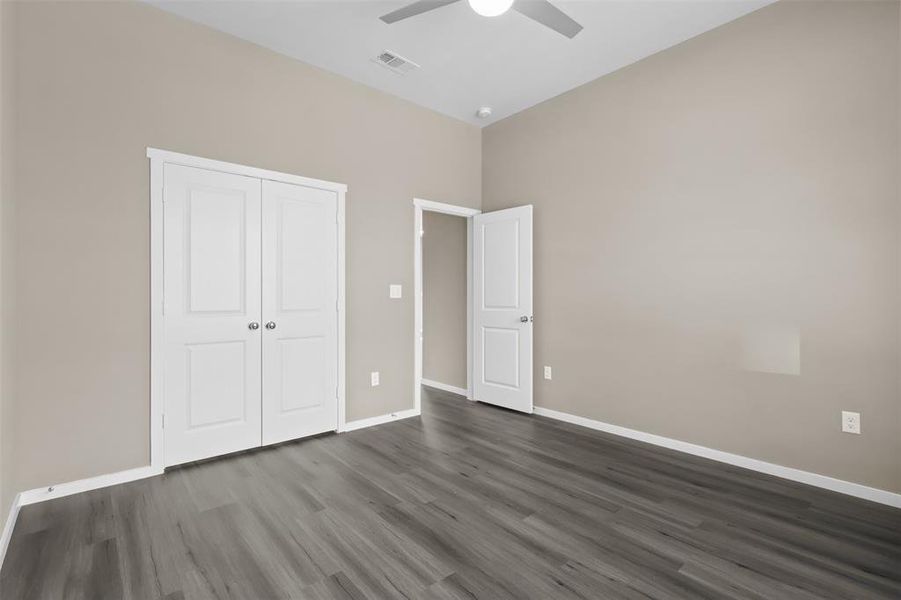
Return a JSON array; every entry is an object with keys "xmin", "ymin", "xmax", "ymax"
[{"xmin": 535, "ymin": 406, "xmax": 901, "ymax": 508}]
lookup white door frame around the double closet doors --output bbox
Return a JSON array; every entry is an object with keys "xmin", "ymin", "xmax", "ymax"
[{"xmin": 147, "ymin": 148, "xmax": 347, "ymax": 473}]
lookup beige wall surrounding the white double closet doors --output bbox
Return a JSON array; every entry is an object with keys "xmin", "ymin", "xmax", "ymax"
[{"xmin": 8, "ymin": 2, "xmax": 481, "ymax": 489}]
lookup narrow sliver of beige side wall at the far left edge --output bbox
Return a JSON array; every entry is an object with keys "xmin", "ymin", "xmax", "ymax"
[{"xmin": 0, "ymin": 2, "xmax": 16, "ymax": 516}]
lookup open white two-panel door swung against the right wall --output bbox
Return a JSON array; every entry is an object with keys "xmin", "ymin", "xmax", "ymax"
[{"xmin": 472, "ymin": 205, "xmax": 532, "ymax": 413}]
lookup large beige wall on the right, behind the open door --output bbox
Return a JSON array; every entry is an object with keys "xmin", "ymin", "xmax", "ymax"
[{"xmin": 483, "ymin": 1, "xmax": 901, "ymax": 492}]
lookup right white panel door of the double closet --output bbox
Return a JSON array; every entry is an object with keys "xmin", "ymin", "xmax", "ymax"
[{"xmin": 263, "ymin": 181, "xmax": 338, "ymax": 444}]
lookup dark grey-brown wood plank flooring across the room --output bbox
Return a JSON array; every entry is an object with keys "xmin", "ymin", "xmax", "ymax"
[{"xmin": 0, "ymin": 390, "xmax": 901, "ymax": 600}]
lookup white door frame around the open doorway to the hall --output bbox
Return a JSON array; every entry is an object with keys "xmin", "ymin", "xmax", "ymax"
[{"xmin": 413, "ymin": 198, "xmax": 482, "ymax": 414}]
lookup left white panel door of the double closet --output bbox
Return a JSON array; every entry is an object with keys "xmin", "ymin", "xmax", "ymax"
[{"xmin": 163, "ymin": 165, "xmax": 262, "ymax": 466}]
